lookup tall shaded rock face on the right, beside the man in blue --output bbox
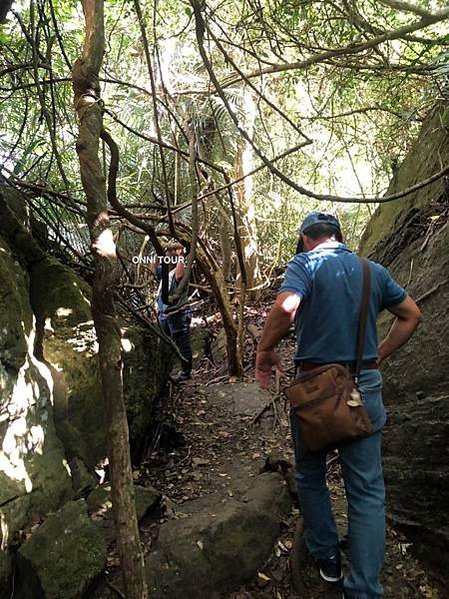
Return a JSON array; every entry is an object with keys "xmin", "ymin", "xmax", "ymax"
[{"xmin": 361, "ymin": 106, "xmax": 449, "ymax": 577}]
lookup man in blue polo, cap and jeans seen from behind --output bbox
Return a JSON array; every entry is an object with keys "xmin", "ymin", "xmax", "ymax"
[{"xmin": 256, "ymin": 212, "xmax": 421, "ymax": 599}]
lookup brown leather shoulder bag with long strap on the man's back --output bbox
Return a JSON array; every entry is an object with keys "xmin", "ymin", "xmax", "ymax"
[{"xmin": 285, "ymin": 258, "xmax": 373, "ymax": 451}]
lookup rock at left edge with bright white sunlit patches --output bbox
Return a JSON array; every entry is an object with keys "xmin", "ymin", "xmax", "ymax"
[{"xmin": 0, "ymin": 355, "xmax": 73, "ymax": 572}]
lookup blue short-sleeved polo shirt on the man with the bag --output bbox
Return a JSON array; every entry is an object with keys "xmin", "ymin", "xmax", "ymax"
[{"xmin": 279, "ymin": 241, "xmax": 407, "ymax": 363}]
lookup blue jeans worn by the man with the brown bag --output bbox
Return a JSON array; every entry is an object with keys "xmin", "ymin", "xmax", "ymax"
[{"xmin": 290, "ymin": 370, "xmax": 386, "ymax": 599}]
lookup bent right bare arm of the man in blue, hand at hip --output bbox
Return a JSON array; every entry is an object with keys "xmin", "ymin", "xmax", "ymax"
[{"xmin": 378, "ymin": 297, "xmax": 422, "ymax": 364}]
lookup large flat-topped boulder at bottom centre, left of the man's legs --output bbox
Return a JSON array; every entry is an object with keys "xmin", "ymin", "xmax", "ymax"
[{"xmin": 146, "ymin": 473, "xmax": 291, "ymax": 599}]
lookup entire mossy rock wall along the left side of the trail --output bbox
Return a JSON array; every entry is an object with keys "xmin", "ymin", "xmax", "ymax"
[{"xmin": 0, "ymin": 186, "xmax": 170, "ymax": 597}]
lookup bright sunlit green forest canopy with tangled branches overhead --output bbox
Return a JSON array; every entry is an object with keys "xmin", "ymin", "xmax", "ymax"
[{"xmin": 0, "ymin": 0, "xmax": 449, "ymax": 268}]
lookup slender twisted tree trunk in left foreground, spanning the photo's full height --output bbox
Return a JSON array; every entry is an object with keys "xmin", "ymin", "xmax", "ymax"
[{"xmin": 72, "ymin": 0, "xmax": 148, "ymax": 599}]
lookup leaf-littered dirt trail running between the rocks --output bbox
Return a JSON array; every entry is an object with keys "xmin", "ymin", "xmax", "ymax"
[{"xmin": 141, "ymin": 341, "xmax": 440, "ymax": 599}]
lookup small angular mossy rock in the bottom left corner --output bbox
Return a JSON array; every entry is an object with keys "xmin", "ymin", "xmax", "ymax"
[{"xmin": 15, "ymin": 500, "xmax": 107, "ymax": 599}]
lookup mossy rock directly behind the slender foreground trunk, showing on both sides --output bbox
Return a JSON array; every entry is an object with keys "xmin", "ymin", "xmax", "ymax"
[{"xmin": 44, "ymin": 323, "xmax": 172, "ymax": 469}]
